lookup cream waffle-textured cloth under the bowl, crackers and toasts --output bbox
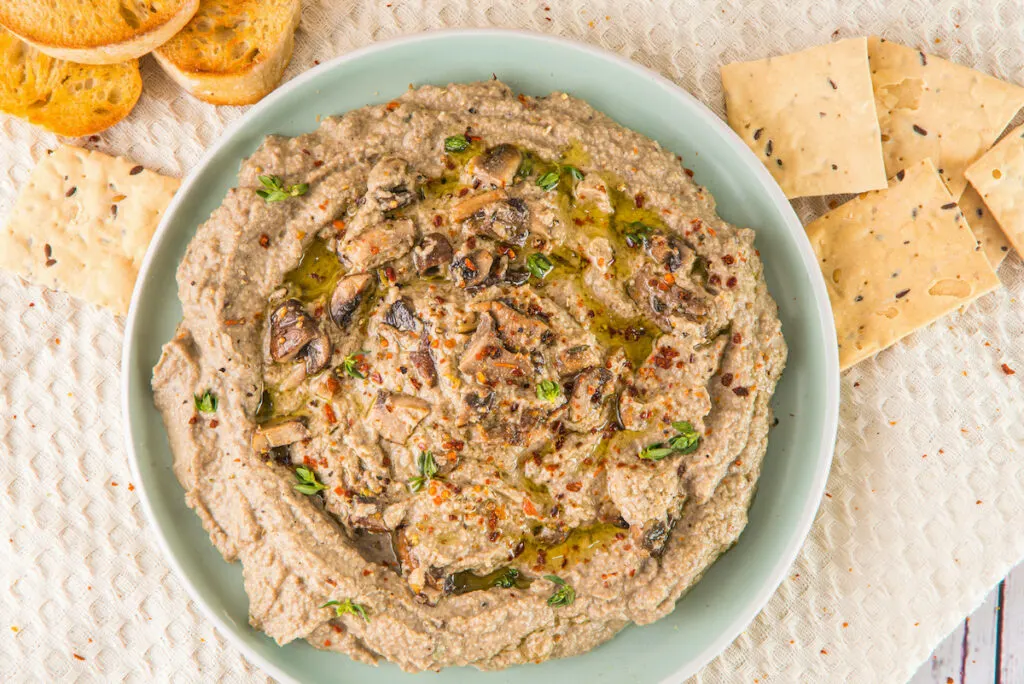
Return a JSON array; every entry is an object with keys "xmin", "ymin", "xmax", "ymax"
[{"xmin": 0, "ymin": 0, "xmax": 1024, "ymax": 682}]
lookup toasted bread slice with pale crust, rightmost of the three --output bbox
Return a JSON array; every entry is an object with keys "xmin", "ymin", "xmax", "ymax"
[{"xmin": 154, "ymin": 0, "xmax": 302, "ymax": 104}]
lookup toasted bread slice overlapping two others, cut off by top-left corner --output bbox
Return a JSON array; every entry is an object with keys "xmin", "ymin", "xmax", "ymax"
[{"xmin": 0, "ymin": 0, "xmax": 200, "ymax": 65}]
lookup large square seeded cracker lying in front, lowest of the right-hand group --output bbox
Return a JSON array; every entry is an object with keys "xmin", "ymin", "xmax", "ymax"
[{"xmin": 807, "ymin": 160, "xmax": 999, "ymax": 370}]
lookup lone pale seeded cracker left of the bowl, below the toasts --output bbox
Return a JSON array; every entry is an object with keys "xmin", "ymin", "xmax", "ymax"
[{"xmin": 0, "ymin": 146, "xmax": 178, "ymax": 314}]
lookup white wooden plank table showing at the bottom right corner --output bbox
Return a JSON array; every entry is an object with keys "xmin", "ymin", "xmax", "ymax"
[{"xmin": 909, "ymin": 564, "xmax": 1024, "ymax": 684}]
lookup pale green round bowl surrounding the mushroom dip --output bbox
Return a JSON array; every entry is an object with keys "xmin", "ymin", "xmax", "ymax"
[{"xmin": 122, "ymin": 30, "xmax": 839, "ymax": 684}]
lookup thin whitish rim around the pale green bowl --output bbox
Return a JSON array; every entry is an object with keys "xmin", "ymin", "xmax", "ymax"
[{"xmin": 121, "ymin": 28, "xmax": 840, "ymax": 684}]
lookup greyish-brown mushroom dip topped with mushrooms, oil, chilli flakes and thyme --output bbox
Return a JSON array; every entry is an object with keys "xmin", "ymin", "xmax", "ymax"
[{"xmin": 153, "ymin": 81, "xmax": 786, "ymax": 671}]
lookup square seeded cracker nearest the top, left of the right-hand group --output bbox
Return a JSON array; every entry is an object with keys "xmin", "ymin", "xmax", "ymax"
[{"xmin": 722, "ymin": 38, "xmax": 886, "ymax": 198}]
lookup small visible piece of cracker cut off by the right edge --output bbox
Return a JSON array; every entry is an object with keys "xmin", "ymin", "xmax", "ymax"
[{"xmin": 967, "ymin": 126, "xmax": 1024, "ymax": 260}]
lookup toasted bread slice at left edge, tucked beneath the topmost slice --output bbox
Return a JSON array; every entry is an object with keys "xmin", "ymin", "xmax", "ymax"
[{"xmin": 0, "ymin": 29, "xmax": 142, "ymax": 137}]
